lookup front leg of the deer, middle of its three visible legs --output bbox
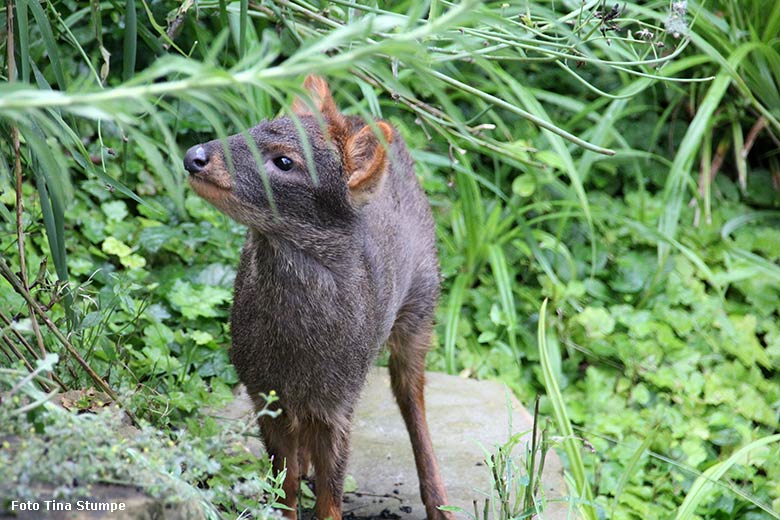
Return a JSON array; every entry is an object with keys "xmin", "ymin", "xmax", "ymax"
[{"xmin": 303, "ymin": 414, "xmax": 350, "ymax": 520}]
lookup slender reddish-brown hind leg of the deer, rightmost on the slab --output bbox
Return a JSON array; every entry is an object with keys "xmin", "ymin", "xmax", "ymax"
[{"xmin": 388, "ymin": 316, "xmax": 454, "ymax": 520}]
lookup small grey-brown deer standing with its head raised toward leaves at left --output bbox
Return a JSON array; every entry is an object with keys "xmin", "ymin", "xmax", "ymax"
[{"xmin": 185, "ymin": 76, "xmax": 452, "ymax": 520}]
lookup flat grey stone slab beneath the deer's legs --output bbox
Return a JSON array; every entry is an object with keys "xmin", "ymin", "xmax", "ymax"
[{"xmin": 219, "ymin": 368, "xmax": 576, "ymax": 520}]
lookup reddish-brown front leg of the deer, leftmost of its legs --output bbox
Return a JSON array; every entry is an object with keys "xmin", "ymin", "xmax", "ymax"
[{"xmin": 259, "ymin": 414, "xmax": 300, "ymax": 520}]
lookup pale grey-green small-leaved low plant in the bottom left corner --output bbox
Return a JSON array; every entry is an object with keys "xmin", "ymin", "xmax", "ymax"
[{"xmin": 0, "ymin": 355, "xmax": 283, "ymax": 518}]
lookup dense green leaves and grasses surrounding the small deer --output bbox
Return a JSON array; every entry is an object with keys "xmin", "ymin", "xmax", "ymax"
[{"xmin": 0, "ymin": 0, "xmax": 780, "ymax": 519}]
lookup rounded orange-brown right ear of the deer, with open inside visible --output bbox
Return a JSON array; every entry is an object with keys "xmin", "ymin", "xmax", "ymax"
[{"xmin": 344, "ymin": 121, "xmax": 393, "ymax": 205}]
